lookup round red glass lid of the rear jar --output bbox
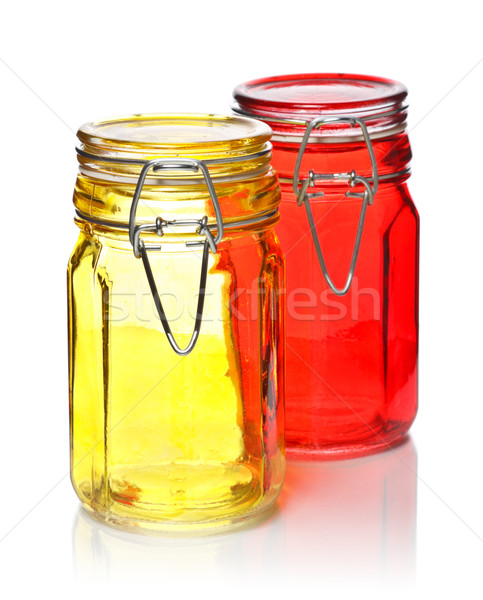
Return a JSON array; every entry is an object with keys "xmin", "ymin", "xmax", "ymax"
[{"xmin": 233, "ymin": 73, "xmax": 407, "ymax": 136}]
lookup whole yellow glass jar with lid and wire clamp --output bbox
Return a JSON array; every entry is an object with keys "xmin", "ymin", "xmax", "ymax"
[{"xmin": 68, "ymin": 115, "xmax": 284, "ymax": 531}]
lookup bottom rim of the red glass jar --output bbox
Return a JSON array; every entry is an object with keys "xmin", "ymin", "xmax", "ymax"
[{"xmin": 286, "ymin": 432, "xmax": 409, "ymax": 461}]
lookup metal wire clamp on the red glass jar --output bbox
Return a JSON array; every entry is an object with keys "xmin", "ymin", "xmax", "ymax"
[{"xmin": 293, "ymin": 117, "xmax": 379, "ymax": 296}]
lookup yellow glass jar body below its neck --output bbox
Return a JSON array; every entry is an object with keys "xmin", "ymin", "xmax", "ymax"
[{"xmin": 68, "ymin": 227, "xmax": 284, "ymax": 531}]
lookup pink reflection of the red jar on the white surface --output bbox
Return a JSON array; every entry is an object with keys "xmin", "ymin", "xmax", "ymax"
[{"xmin": 279, "ymin": 439, "xmax": 418, "ymax": 583}]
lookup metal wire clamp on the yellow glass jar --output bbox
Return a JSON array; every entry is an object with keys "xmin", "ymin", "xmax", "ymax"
[{"xmin": 129, "ymin": 158, "xmax": 223, "ymax": 356}]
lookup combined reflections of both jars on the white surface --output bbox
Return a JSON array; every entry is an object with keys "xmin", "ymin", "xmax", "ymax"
[{"xmin": 72, "ymin": 439, "xmax": 418, "ymax": 584}]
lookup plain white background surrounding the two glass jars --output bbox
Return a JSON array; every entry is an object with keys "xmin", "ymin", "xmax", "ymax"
[{"xmin": 0, "ymin": 0, "xmax": 483, "ymax": 598}]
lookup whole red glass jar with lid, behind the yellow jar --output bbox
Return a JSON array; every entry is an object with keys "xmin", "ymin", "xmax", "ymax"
[{"xmin": 234, "ymin": 74, "xmax": 419, "ymax": 458}]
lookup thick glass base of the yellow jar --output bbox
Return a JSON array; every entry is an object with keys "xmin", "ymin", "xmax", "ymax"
[{"xmin": 73, "ymin": 462, "xmax": 279, "ymax": 535}]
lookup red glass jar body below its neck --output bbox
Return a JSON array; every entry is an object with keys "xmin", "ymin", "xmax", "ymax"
[{"xmin": 277, "ymin": 176, "xmax": 419, "ymax": 458}]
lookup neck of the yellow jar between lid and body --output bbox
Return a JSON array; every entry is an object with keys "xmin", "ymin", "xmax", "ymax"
[{"xmin": 74, "ymin": 167, "xmax": 280, "ymax": 253}]
